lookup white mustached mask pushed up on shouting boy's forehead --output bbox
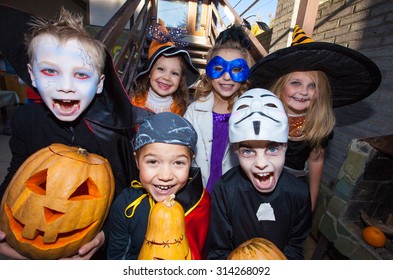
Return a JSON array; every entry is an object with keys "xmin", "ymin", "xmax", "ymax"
[{"xmin": 229, "ymin": 88, "xmax": 288, "ymax": 143}]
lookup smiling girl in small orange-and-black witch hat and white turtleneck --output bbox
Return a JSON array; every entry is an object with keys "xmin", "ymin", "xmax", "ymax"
[{"xmin": 132, "ymin": 20, "xmax": 199, "ymax": 116}]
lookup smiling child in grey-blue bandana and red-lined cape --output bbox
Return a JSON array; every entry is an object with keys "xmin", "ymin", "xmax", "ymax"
[{"xmin": 107, "ymin": 112, "xmax": 210, "ymax": 259}]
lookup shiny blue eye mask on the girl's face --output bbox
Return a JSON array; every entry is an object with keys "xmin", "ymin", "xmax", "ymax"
[{"xmin": 206, "ymin": 56, "xmax": 250, "ymax": 83}]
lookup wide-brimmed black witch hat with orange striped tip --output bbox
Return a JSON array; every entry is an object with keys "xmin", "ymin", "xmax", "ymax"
[{"xmin": 250, "ymin": 25, "xmax": 381, "ymax": 107}]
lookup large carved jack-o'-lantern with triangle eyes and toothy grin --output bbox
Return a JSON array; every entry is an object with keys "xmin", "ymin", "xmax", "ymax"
[{"xmin": 0, "ymin": 144, "xmax": 114, "ymax": 259}]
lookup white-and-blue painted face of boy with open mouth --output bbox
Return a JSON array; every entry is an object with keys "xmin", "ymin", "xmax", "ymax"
[{"xmin": 28, "ymin": 34, "xmax": 104, "ymax": 122}]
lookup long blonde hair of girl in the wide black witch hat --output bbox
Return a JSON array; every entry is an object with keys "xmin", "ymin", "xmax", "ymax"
[{"xmin": 270, "ymin": 71, "xmax": 336, "ymax": 151}]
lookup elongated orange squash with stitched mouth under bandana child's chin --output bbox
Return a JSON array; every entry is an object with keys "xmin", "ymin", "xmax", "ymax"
[{"xmin": 138, "ymin": 194, "xmax": 191, "ymax": 260}]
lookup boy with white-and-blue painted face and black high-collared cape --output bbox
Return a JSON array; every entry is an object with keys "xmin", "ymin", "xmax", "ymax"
[{"xmin": 0, "ymin": 5, "xmax": 150, "ymax": 258}]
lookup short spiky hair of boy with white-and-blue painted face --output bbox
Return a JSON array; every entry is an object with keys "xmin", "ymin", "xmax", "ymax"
[{"xmin": 25, "ymin": 8, "xmax": 106, "ymax": 74}]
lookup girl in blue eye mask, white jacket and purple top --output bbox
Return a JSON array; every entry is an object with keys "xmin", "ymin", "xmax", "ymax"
[{"xmin": 184, "ymin": 25, "xmax": 252, "ymax": 192}]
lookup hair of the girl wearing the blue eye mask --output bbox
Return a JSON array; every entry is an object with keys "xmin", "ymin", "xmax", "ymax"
[{"xmin": 194, "ymin": 26, "xmax": 254, "ymax": 111}]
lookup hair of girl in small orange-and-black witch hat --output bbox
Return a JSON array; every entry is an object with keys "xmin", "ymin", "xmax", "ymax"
[{"xmin": 131, "ymin": 55, "xmax": 189, "ymax": 116}]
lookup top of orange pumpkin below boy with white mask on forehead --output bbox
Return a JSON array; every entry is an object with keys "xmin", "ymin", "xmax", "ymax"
[{"xmin": 228, "ymin": 237, "xmax": 287, "ymax": 260}]
